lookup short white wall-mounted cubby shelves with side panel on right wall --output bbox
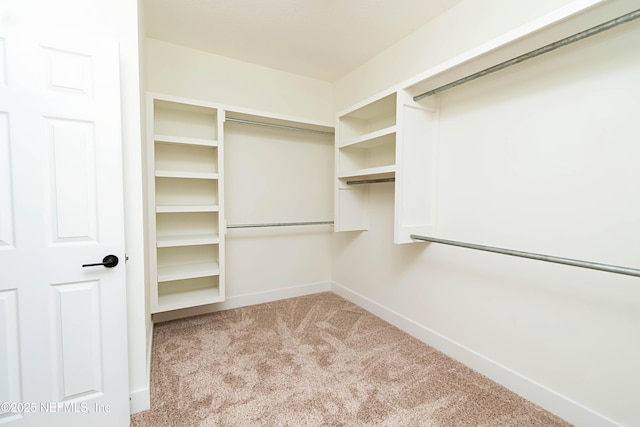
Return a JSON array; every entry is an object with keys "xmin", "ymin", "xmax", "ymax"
[{"xmin": 335, "ymin": 90, "xmax": 437, "ymax": 243}]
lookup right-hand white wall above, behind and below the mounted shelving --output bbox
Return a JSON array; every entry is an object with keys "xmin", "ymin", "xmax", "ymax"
[{"xmin": 333, "ymin": 0, "xmax": 640, "ymax": 425}]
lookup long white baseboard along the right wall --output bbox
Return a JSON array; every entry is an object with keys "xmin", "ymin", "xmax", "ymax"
[{"xmin": 331, "ymin": 283, "xmax": 619, "ymax": 427}]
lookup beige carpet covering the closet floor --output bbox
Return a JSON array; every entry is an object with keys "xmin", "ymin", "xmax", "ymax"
[{"xmin": 131, "ymin": 292, "xmax": 569, "ymax": 427}]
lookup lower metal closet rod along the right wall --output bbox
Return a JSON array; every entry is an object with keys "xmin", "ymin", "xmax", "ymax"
[{"xmin": 409, "ymin": 234, "xmax": 640, "ymax": 277}]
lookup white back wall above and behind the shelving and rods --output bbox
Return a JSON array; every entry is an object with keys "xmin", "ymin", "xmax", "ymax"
[{"xmin": 146, "ymin": 39, "xmax": 333, "ymax": 321}]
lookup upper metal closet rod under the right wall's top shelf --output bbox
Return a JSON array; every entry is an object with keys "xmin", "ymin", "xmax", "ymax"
[{"xmin": 413, "ymin": 9, "xmax": 640, "ymax": 101}]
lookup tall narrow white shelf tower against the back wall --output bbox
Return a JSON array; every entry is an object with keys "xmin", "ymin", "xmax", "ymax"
[{"xmin": 148, "ymin": 94, "xmax": 224, "ymax": 313}]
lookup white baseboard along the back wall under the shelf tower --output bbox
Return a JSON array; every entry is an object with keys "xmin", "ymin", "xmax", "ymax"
[{"xmin": 153, "ymin": 282, "xmax": 331, "ymax": 323}]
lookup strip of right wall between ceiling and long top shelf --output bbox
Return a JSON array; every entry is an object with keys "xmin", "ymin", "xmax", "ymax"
[{"xmin": 334, "ymin": 0, "xmax": 616, "ymax": 111}]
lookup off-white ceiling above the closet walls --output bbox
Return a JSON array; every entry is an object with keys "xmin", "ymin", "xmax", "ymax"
[{"xmin": 144, "ymin": 0, "xmax": 458, "ymax": 82}]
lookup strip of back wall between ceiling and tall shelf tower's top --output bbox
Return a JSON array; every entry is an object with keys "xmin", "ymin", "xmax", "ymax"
[{"xmin": 146, "ymin": 39, "xmax": 333, "ymax": 122}]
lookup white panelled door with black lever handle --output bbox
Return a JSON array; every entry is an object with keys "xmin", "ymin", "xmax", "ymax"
[{"xmin": 0, "ymin": 22, "xmax": 129, "ymax": 427}]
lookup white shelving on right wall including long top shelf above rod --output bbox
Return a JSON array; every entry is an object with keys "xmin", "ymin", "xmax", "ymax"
[{"xmin": 335, "ymin": 0, "xmax": 639, "ymax": 243}]
